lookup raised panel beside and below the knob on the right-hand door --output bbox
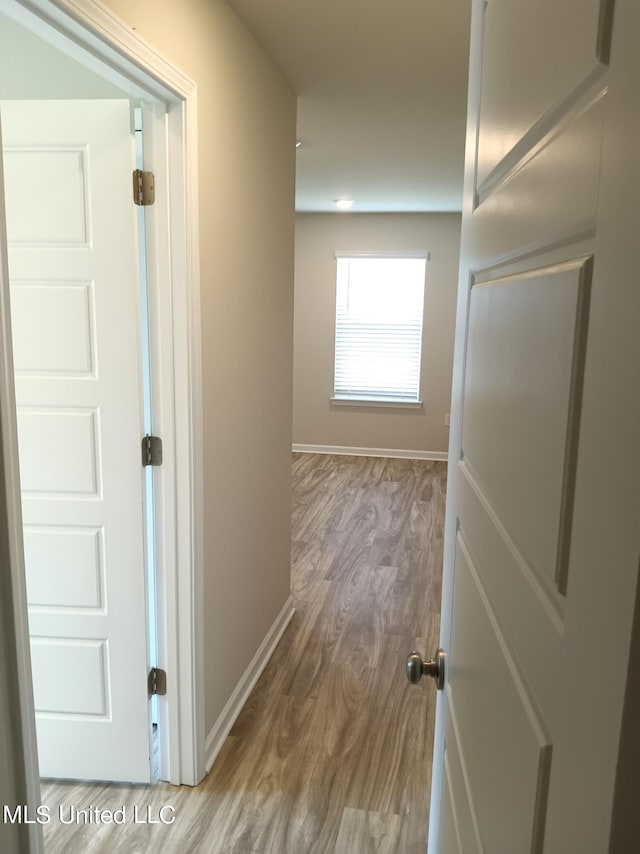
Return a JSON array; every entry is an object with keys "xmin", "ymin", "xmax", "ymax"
[{"xmin": 448, "ymin": 534, "xmax": 551, "ymax": 854}]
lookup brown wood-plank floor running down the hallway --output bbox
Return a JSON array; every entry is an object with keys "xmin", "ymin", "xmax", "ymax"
[{"xmin": 43, "ymin": 454, "xmax": 446, "ymax": 854}]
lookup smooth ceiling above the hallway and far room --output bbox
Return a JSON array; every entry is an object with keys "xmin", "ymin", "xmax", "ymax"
[{"xmin": 229, "ymin": 0, "xmax": 470, "ymax": 212}]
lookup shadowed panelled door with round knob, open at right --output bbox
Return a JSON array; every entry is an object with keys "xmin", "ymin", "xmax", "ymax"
[{"xmin": 429, "ymin": 0, "xmax": 640, "ymax": 854}]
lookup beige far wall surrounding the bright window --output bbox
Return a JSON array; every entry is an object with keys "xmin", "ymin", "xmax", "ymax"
[{"xmin": 293, "ymin": 213, "xmax": 460, "ymax": 453}]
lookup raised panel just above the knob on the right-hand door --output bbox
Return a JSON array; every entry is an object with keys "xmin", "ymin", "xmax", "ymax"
[{"xmin": 462, "ymin": 258, "xmax": 591, "ymax": 592}]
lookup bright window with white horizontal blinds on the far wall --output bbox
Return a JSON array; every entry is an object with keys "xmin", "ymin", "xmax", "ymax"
[{"xmin": 332, "ymin": 252, "xmax": 428, "ymax": 405}]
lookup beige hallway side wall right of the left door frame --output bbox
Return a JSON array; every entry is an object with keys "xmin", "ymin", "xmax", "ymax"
[{"xmin": 102, "ymin": 0, "xmax": 296, "ymax": 731}]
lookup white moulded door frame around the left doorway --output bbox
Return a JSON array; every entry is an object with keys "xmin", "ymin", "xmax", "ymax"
[{"xmin": 0, "ymin": 0, "xmax": 205, "ymax": 791}]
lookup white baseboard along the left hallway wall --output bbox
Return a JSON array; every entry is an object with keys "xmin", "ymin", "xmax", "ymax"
[{"xmin": 205, "ymin": 596, "xmax": 295, "ymax": 773}]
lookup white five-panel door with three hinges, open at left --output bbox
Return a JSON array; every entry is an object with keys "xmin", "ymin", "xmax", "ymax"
[{"xmin": 1, "ymin": 100, "xmax": 150, "ymax": 782}]
